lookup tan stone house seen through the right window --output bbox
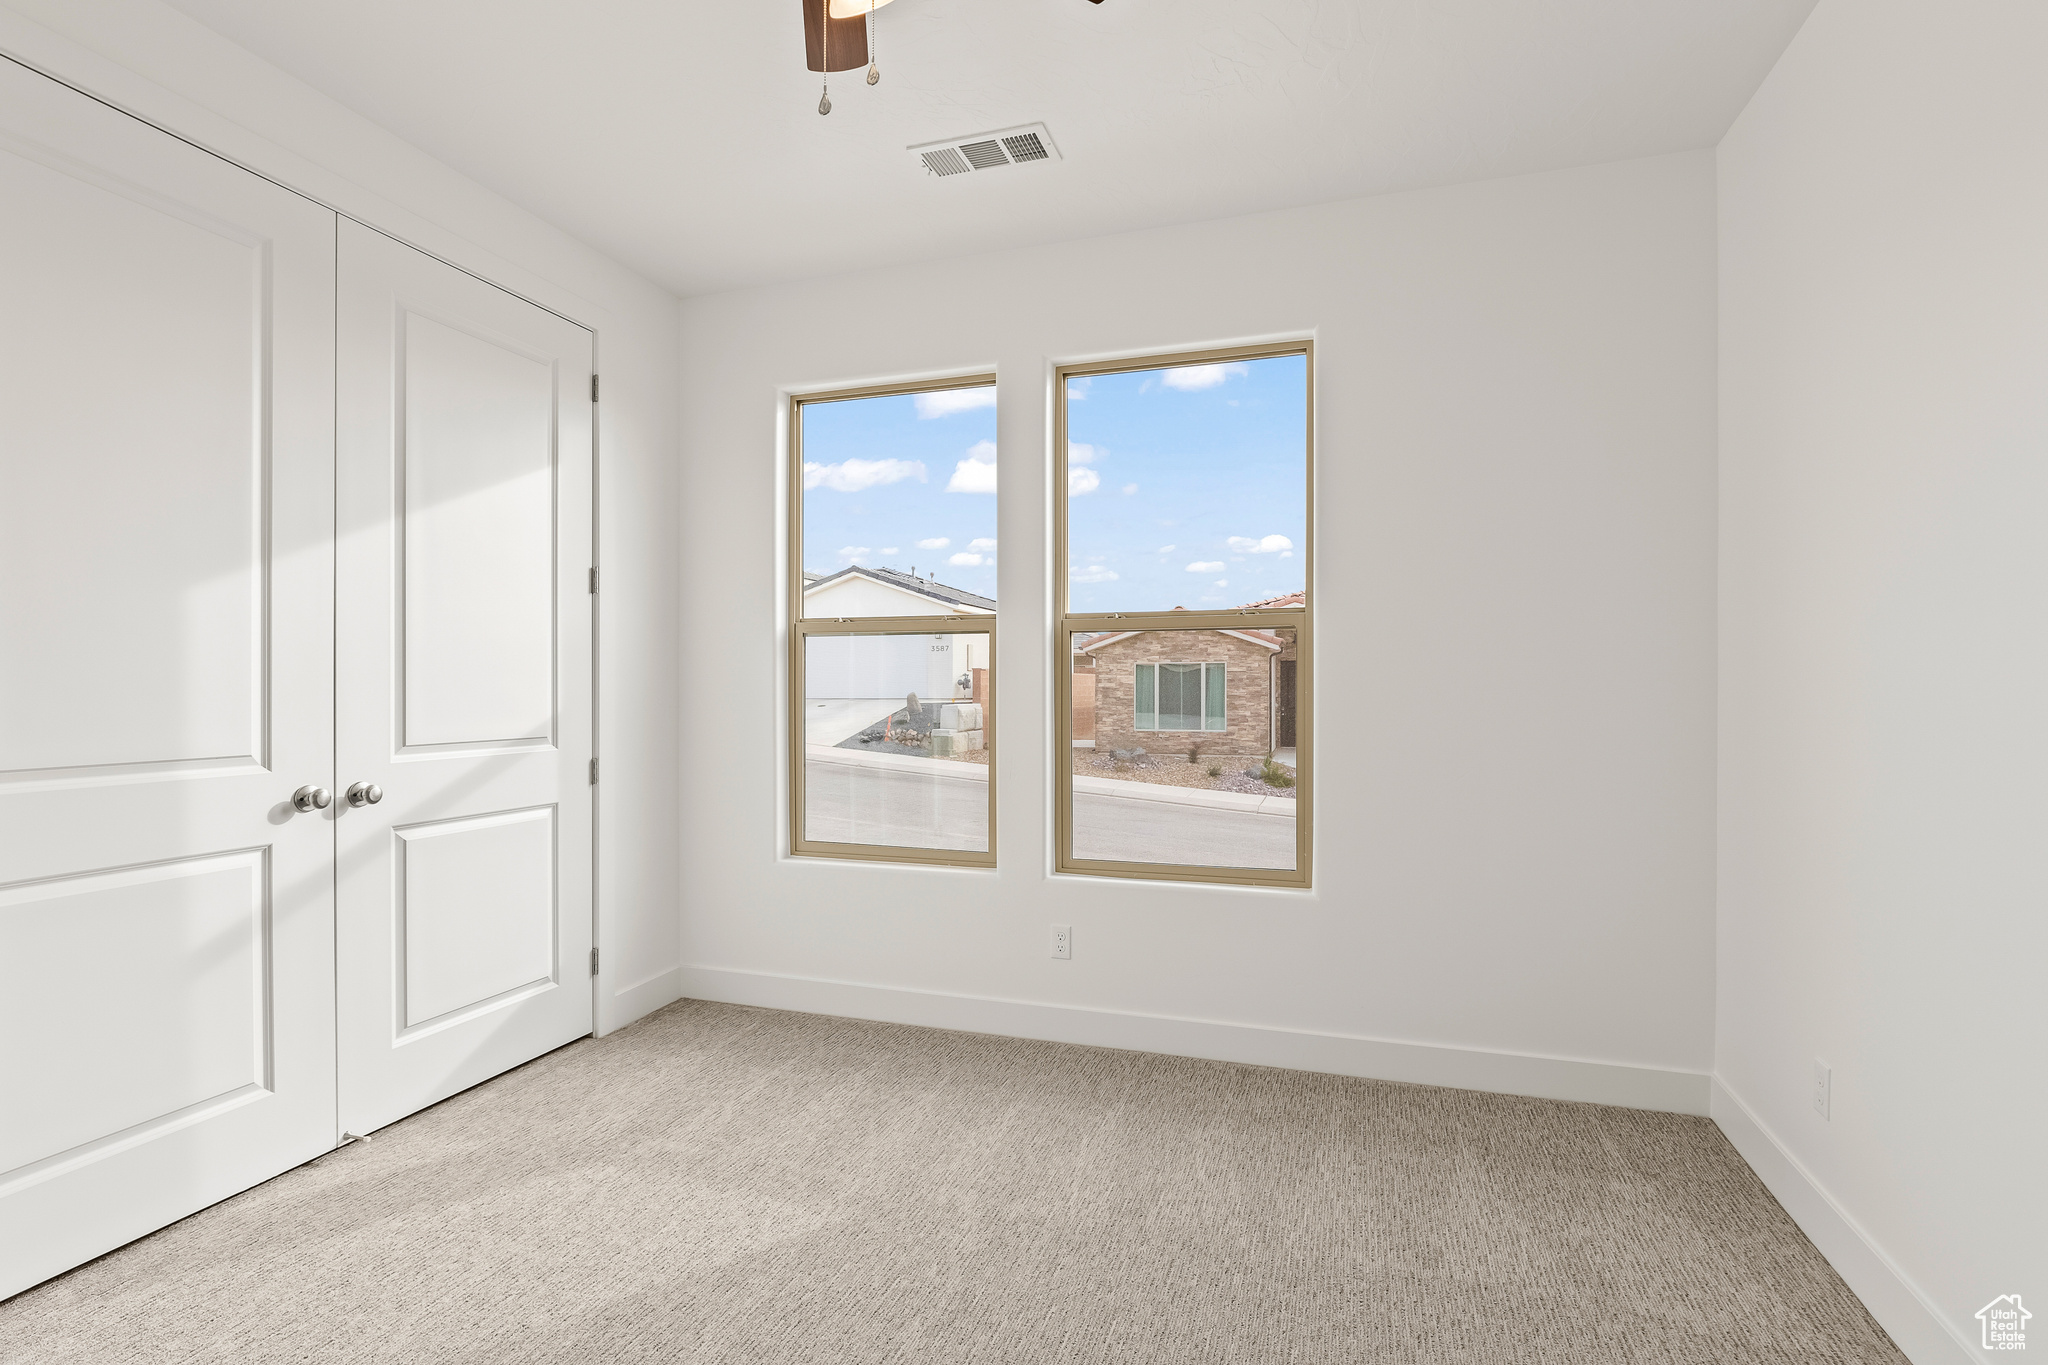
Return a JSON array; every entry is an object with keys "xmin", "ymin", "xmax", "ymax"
[{"xmin": 1073, "ymin": 593, "xmax": 1300, "ymax": 753}]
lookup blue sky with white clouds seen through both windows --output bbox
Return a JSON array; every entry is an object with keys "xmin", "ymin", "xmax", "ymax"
[{"xmin": 803, "ymin": 356, "xmax": 1309, "ymax": 612}]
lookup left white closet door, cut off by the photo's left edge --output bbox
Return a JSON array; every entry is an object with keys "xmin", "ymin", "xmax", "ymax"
[{"xmin": 0, "ymin": 59, "xmax": 336, "ymax": 1297}]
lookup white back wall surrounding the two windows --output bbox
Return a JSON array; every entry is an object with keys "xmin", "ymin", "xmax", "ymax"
[{"xmin": 680, "ymin": 151, "xmax": 1714, "ymax": 1111}]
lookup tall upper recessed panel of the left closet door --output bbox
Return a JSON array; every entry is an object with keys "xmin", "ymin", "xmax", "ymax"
[{"xmin": 0, "ymin": 98, "xmax": 268, "ymax": 780}]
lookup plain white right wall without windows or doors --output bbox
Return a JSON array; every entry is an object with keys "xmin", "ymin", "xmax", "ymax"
[{"xmin": 1716, "ymin": 0, "xmax": 2048, "ymax": 1361}]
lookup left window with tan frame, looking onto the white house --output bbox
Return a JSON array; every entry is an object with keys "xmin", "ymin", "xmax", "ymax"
[{"xmin": 788, "ymin": 377, "xmax": 997, "ymax": 868}]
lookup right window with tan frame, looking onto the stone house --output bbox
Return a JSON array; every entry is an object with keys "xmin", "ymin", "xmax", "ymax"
[{"xmin": 1053, "ymin": 342, "xmax": 1313, "ymax": 886}]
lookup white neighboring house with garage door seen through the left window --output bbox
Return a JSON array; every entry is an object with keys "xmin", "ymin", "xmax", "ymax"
[{"xmin": 803, "ymin": 567, "xmax": 995, "ymax": 704}]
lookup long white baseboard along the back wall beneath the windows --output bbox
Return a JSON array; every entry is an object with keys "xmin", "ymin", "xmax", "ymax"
[{"xmin": 682, "ymin": 966, "xmax": 1708, "ymax": 1115}]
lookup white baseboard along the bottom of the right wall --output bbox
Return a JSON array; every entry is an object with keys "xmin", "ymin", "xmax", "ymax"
[{"xmin": 1712, "ymin": 1076, "xmax": 1980, "ymax": 1365}]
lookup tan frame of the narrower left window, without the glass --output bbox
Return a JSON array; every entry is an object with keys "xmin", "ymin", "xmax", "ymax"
[{"xmin": 788, "ymin": 375, "xmax": 997, "ymax": 868}]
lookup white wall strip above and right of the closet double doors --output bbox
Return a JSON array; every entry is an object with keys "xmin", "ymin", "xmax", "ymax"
[{"xmin": 0, "ymin": 0, "xmax": 680, "ymax": 1027}]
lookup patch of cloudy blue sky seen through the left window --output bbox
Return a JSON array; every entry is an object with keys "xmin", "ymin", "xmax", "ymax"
[{"xmin": 803, "ymin": 385, "xmax": 997, "ymax": 598}]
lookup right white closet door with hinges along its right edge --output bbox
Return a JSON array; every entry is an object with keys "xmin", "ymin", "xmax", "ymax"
[{"xmin": 336, "ymin": 221, "xmax": 592, "ymax": 1134}]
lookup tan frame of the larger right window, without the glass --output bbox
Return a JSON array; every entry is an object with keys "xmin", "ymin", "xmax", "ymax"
[{"xmin": 1053, "ymin": 340, "xmax": 1315, "ymax": 888}]
